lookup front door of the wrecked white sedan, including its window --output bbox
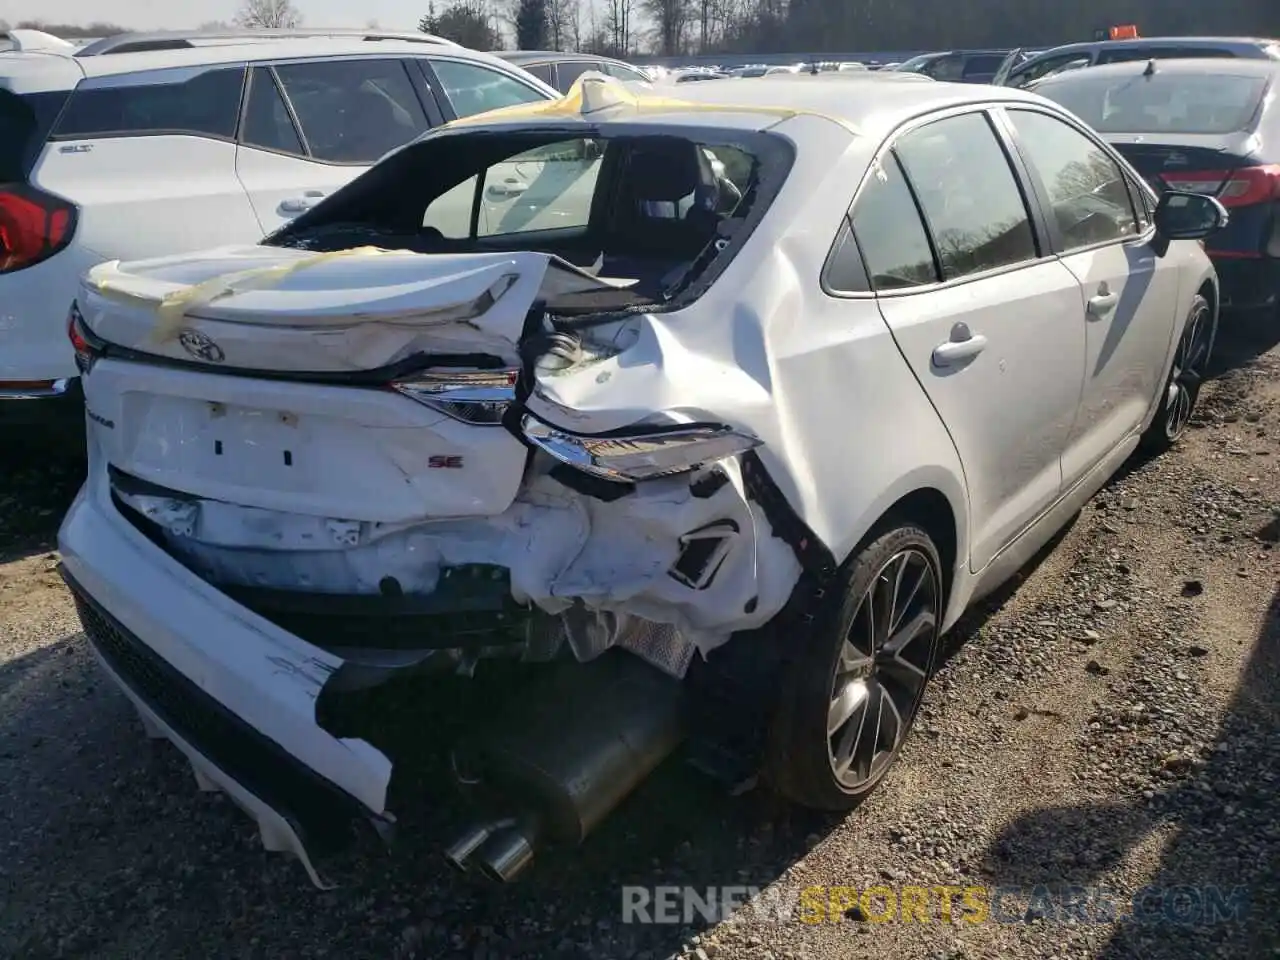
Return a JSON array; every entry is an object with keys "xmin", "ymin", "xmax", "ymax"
[{"xmin": 1006, "ymin": 108, "xmax": 1179, "ymax": 485}]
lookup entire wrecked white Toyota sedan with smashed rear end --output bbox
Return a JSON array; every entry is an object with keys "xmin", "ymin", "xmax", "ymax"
[{"xmin": 60, "ymin": 74, "xmax": 1226, "ymax": 883}]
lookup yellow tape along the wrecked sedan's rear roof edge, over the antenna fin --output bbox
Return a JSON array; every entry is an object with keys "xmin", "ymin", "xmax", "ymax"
[{"xmin": 447, "ymin": 73, "xmax": 860, "ymax": 133}]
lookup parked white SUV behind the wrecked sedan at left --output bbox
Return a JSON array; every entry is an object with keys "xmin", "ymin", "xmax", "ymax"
[{"xmin": 0, "ymin": 36, "xmax": 558, "ymax": 424}]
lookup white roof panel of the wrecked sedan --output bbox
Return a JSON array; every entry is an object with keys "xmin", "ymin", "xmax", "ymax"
[{"xmin": 450, "ymin": 72, "xmax": 1060, "ymax": 138}]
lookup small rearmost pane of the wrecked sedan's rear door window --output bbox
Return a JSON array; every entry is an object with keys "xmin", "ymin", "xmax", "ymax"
[{"xmin": 854, "ymin": 154, "xmax": 938, "ymax": 291}]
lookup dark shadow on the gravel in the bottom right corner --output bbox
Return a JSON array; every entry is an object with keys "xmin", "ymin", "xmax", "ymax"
[{"xmin": 986, "ymin": 590, "xmax": 1280, "ymax": 960}]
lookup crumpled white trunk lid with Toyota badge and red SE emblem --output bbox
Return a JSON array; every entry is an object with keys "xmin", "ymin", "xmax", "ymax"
[{"xmin": 78, "ymin": 247, "xmax": 640, "ymax": 522}]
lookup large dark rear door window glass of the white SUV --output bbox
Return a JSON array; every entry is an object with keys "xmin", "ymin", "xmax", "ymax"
[{"xmin": 276, "ymin": 60, "xmax": 428, "ymax": 164}]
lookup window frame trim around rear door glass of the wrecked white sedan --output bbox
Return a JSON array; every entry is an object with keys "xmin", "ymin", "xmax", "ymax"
[{"xmin": 819, "ymin": 102, "xmax": 1061, "ymax": 300}]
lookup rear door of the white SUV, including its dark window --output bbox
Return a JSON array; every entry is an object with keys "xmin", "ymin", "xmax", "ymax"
[{"xmin": 236, "ymin": 58, "xmax": 430, "ymax": 233}]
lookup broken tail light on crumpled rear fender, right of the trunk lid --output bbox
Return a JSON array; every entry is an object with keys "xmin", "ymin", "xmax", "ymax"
[{"xmin": 521, "ymin": 415, "xmax": 762, "ymax": 483}]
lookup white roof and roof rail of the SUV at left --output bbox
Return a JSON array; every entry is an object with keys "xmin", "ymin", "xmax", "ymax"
[{"xmin": 0, "ymin": 37, "xmax": 527, "ymax": 90}]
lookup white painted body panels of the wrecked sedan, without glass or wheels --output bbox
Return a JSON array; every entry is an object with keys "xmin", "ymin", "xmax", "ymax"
[{"xmin": 60, "ymin": 74, "xmax": 1213, "ymax": 885}]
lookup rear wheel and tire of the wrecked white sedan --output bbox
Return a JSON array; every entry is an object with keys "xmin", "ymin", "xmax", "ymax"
[{"xmin": 765, "ymin": 521, "xmax": 943, "ymax": 810}]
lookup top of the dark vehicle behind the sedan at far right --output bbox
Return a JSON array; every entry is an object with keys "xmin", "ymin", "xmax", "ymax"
[{"xmin": 997, "ymin": 37, "xmax": 1280, "ymax": 90}]
